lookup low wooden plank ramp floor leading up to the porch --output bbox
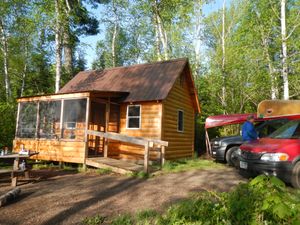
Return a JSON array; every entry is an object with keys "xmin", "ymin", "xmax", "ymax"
[{"xmin": 86, "ymin": 157, "xmax": 144, "ymax": 174}]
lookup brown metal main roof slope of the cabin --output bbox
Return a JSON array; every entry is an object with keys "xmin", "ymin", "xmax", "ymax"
[{"xmin": 58, "ymin": 58, "xmax": 199, "ymax": 111}]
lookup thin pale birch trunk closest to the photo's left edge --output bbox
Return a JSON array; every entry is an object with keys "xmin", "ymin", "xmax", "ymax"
[{"xmin": 0, "ymin": 19, "xmax": 11, "ymax": 101}]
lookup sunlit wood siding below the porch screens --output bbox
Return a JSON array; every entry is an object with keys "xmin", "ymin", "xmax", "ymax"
[{"xmin": 14, "ymin": 139, "xmax": 85, "ymax": 163}]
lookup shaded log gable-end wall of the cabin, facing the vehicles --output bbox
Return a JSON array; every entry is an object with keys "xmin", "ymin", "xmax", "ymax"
[{"xmin": 161, "ymin": 71, "xmax": 195, "ymax": 160}]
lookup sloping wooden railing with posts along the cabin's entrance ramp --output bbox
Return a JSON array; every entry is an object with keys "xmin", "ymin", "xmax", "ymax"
[{"xmin": 86, "ymin": 130, "xmax": 168, "ymax": 173}]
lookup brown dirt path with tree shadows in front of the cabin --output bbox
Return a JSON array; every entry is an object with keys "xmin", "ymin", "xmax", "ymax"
[{"xmin": 0, "ymin": 168, "xmax": 243, "ymax": 225}]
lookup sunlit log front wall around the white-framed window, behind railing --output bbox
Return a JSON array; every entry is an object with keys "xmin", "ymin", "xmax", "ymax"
[{"xmin": 119, "ymin": 101, "xmax": 162, "ymax": 160}]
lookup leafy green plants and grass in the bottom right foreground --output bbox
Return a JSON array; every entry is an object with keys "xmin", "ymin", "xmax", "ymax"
[{"xmin": 102, "ymin": 175, "xmax": 300, "ymax": 225}]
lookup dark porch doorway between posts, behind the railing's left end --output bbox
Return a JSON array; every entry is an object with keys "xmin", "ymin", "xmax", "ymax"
[{"xmin": 88, "ymin": 101, "xmax": 105, "ymax": 157}]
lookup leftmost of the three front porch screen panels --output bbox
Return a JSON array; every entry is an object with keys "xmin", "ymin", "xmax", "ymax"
[{"xmin": 16, "ymin": 102, "xmax": 37, "ymax": 138}]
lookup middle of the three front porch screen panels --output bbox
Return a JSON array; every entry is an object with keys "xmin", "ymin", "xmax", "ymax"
[{"xmin": 38, "ymin": 100, "xmax": 61, "ymax": 139}]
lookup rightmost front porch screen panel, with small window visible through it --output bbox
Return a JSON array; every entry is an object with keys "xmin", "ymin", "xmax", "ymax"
[{"xmin": 63, "ymin": 99, "xmax": 87, "ymax": 140}]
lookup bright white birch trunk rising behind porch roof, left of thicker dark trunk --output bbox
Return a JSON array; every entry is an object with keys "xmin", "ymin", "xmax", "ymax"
[{"xmin": 55, "ymin": 0, "xmax": 62, "ymax": 93}]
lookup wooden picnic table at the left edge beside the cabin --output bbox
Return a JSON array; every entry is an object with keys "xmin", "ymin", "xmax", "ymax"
[{"xmin": 0, "ymin": 152, "xmax": 38, "ymax": 187}]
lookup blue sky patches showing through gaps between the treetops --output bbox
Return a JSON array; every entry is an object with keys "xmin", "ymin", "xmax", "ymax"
[{"xmin": 80, "ymin": 0, "xmax": 231, "ymax": 69}]
